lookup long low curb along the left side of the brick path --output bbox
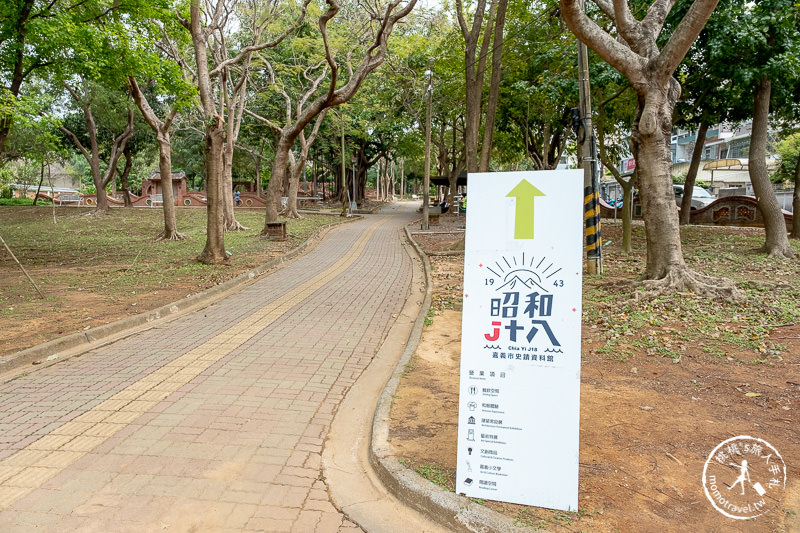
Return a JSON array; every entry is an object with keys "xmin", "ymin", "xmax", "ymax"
[{"xmin": 0, "ymin": 216, "xmax": 361, "ymax": 384}]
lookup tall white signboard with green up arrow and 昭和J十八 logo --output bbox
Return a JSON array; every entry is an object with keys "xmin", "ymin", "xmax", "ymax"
[{"xmin": 456, "ymin": 170, "xmax": 583, "ymax": 511}]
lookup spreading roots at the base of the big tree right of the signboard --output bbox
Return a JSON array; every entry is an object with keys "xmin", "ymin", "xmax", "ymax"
[{"xmin": 634, "ymin": 267, "xmax": 744, "ymax": 301}]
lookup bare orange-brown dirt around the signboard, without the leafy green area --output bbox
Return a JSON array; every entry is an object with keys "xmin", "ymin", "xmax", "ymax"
[{"xmin": 390, "ymin": 213, "xmax": 800, "ymax": 532}]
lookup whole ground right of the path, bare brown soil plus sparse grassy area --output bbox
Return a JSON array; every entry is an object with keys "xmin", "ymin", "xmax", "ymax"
[{"xmin": 390, "ymin": 217, "xmax": 800, "ymax": 532}]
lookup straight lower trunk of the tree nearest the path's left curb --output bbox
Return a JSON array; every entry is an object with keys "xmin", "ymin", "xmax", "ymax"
[{"xmin": 197, "ymin": 118, "xmax": 228, "ymax": 265}]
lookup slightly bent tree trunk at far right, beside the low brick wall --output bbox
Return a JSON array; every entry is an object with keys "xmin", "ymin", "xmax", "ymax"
[{"xmin": 748, "ymin": 75, "xmax": 794, "ymax": 258}]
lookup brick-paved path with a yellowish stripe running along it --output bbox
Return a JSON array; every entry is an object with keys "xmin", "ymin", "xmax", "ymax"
[{"xmin": 0, "ymin": 202, "xmax": 413, "ymax": 533}]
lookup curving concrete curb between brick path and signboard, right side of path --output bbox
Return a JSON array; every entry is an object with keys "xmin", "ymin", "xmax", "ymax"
[{"xmin": 369, "ymin": 227, "xmax": 532, "ymax": 532}]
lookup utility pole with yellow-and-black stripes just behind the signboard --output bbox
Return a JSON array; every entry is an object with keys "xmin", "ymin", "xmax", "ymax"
[{"xmin": 578, "ymin": 2, "xmax": 603, "ymax": 274}]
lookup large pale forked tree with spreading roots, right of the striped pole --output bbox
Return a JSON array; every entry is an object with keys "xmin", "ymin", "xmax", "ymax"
[{"xmin": 559, "ymin": 0, "xmax": 739, "ymax": 298}]
